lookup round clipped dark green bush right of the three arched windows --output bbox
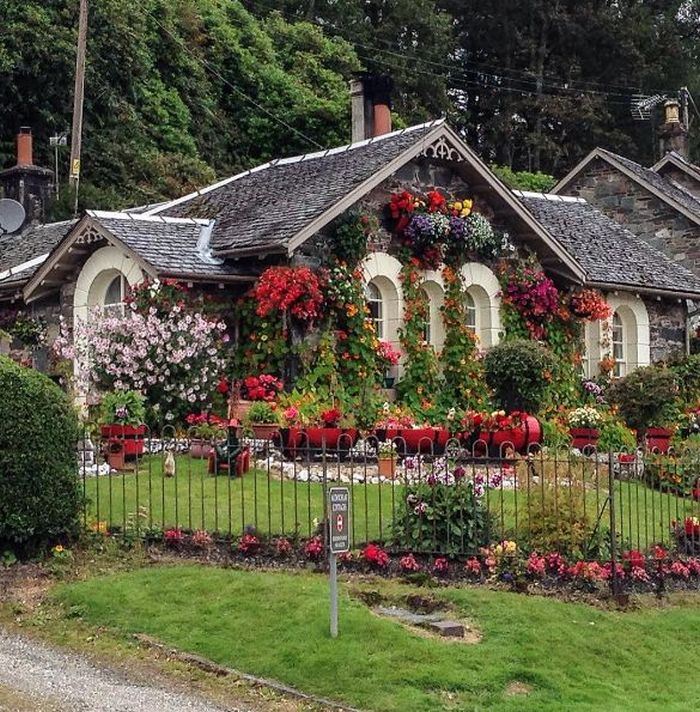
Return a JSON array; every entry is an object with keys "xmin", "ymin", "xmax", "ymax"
[{"xmin": 484, "ymin": 339, "xmax": 553, "ymax": 413}]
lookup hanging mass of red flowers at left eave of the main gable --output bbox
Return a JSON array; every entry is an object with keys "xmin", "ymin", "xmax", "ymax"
[{"xmin": 252, "ymin": 267, "xmax": 323, "ymax": 323}]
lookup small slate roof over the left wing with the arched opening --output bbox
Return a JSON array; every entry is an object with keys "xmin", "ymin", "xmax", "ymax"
[{"xmin": 87, "ymin": 211, "xmax": 251, "ymax": 278}]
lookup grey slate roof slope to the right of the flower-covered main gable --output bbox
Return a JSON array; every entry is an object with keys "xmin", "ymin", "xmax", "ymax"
[{"xmin": 515, "ymin": 191, "xmax": 700, "ymax": 295}]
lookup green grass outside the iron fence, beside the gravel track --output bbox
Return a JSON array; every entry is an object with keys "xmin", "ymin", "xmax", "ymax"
[{"xmin": 56, "ymin": 565, "xmax": 700, "ymax": 712}]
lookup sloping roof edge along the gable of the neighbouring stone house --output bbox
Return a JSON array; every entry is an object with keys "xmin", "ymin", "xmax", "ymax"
[{"xmin": 552, "ymin": 148, "xmax": 700, "ymax": 225}]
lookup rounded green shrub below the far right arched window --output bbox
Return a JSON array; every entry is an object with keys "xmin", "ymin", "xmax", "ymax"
[{"xmin": 607, "ymin": 366, "xmax": 678, "ymax": 432}]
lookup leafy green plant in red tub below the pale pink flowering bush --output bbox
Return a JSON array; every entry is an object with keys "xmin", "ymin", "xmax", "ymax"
[{"xmin": 100, "ymin": 391, "xmax": 146, "ymax": 469}]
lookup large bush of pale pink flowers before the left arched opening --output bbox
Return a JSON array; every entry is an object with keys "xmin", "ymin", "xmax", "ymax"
[{"xmin": 54, "ymin": 304, "xmax": 228, "ymax": 420}]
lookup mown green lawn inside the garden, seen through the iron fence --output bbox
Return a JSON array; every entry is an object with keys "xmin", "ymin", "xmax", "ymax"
[{"xmin": 85, "ymin": 456, "xmax": 700, "ymax": 548}]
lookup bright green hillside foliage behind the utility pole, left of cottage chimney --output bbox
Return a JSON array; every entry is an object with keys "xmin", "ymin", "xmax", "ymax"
[{"xmin": 0, "ymin": 0, "xmax": 360, "ymax": 211}]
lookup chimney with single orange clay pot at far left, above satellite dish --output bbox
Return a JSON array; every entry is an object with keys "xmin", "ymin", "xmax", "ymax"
[{"xmin": 0, "ymin": 126, "xmax": 53, "ymax": 227}]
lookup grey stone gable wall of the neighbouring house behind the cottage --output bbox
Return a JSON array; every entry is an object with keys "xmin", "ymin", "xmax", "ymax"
[{"xmin": 566, "ymin": 159, "xmax": 700, "ymax": 274}]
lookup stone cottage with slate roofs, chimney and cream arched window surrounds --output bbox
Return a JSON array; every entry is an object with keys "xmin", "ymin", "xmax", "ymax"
[{"xmin": 0, "ymin": 85, "xmax": 700, "ymax": 376}]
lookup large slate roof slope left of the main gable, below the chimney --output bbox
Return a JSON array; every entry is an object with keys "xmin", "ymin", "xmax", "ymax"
[{"xmin": 156, "ymin": 121, "xmax": 444, "ymax": 254}]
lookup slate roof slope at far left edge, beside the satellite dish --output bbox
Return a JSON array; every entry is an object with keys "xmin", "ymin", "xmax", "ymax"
[{"xmin": 0, "ymin": 220, "xmax": 77, "ymax": 288}]
